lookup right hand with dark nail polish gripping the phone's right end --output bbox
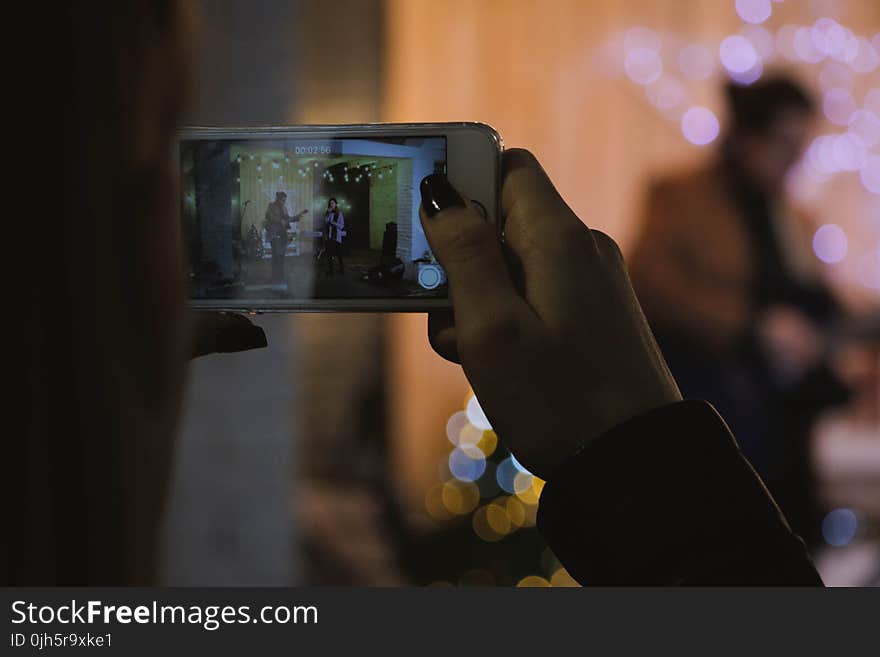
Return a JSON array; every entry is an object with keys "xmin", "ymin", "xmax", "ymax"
[{"xmin": 420, "ymin": 150, "xmax": 681, "ymax": 478}]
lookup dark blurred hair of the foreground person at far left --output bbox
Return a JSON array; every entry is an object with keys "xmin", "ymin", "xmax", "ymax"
[{"xmin": 23, "ymin": 0, "xmax": 192, "ymax": 585}]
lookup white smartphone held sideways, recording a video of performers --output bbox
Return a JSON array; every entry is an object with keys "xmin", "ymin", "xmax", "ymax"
[{"xmin": 177, "ymin": 123, "xmax": 502, "ymax": 312}]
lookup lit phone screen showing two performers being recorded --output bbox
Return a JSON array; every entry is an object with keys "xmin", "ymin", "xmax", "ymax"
[{"xmin": 180, "ymin": 136, "xmax": 447, "ymax": 301}]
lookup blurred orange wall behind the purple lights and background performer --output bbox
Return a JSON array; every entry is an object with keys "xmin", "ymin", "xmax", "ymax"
[{"xmin": 382, "ymin": 0, "xmax": 880, "ymax": 509}]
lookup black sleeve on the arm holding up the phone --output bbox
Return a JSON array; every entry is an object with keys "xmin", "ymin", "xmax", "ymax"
[{"xmin": 538, "ymin": 401, "xmax": 822, "ymax": 586}]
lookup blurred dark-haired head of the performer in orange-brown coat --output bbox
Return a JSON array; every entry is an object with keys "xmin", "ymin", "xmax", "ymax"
[{"xmin": 724, "ymin": 77, "xmax": 815, "ymax": 194}]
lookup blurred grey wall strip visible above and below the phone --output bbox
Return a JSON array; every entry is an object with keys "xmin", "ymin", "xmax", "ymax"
[{"xmin": 162, "ymin": 0, "xmax": 300, "ymax": 586}]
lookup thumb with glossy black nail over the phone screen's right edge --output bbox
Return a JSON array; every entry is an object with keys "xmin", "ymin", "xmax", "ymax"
[{"xmin": 419, "ymin": 173, "xmax": 517, "ymax": 318}]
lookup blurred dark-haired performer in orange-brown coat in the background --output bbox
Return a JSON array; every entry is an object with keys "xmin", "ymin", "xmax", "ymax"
[{"xmin": 630, "ymin": 77, "xmax": 846, "ymax": 542}]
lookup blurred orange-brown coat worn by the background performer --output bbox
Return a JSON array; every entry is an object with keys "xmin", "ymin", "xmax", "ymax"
[{"xmin": 629, "ymin": 166, "xmax": 815, "ymax": 354}]
